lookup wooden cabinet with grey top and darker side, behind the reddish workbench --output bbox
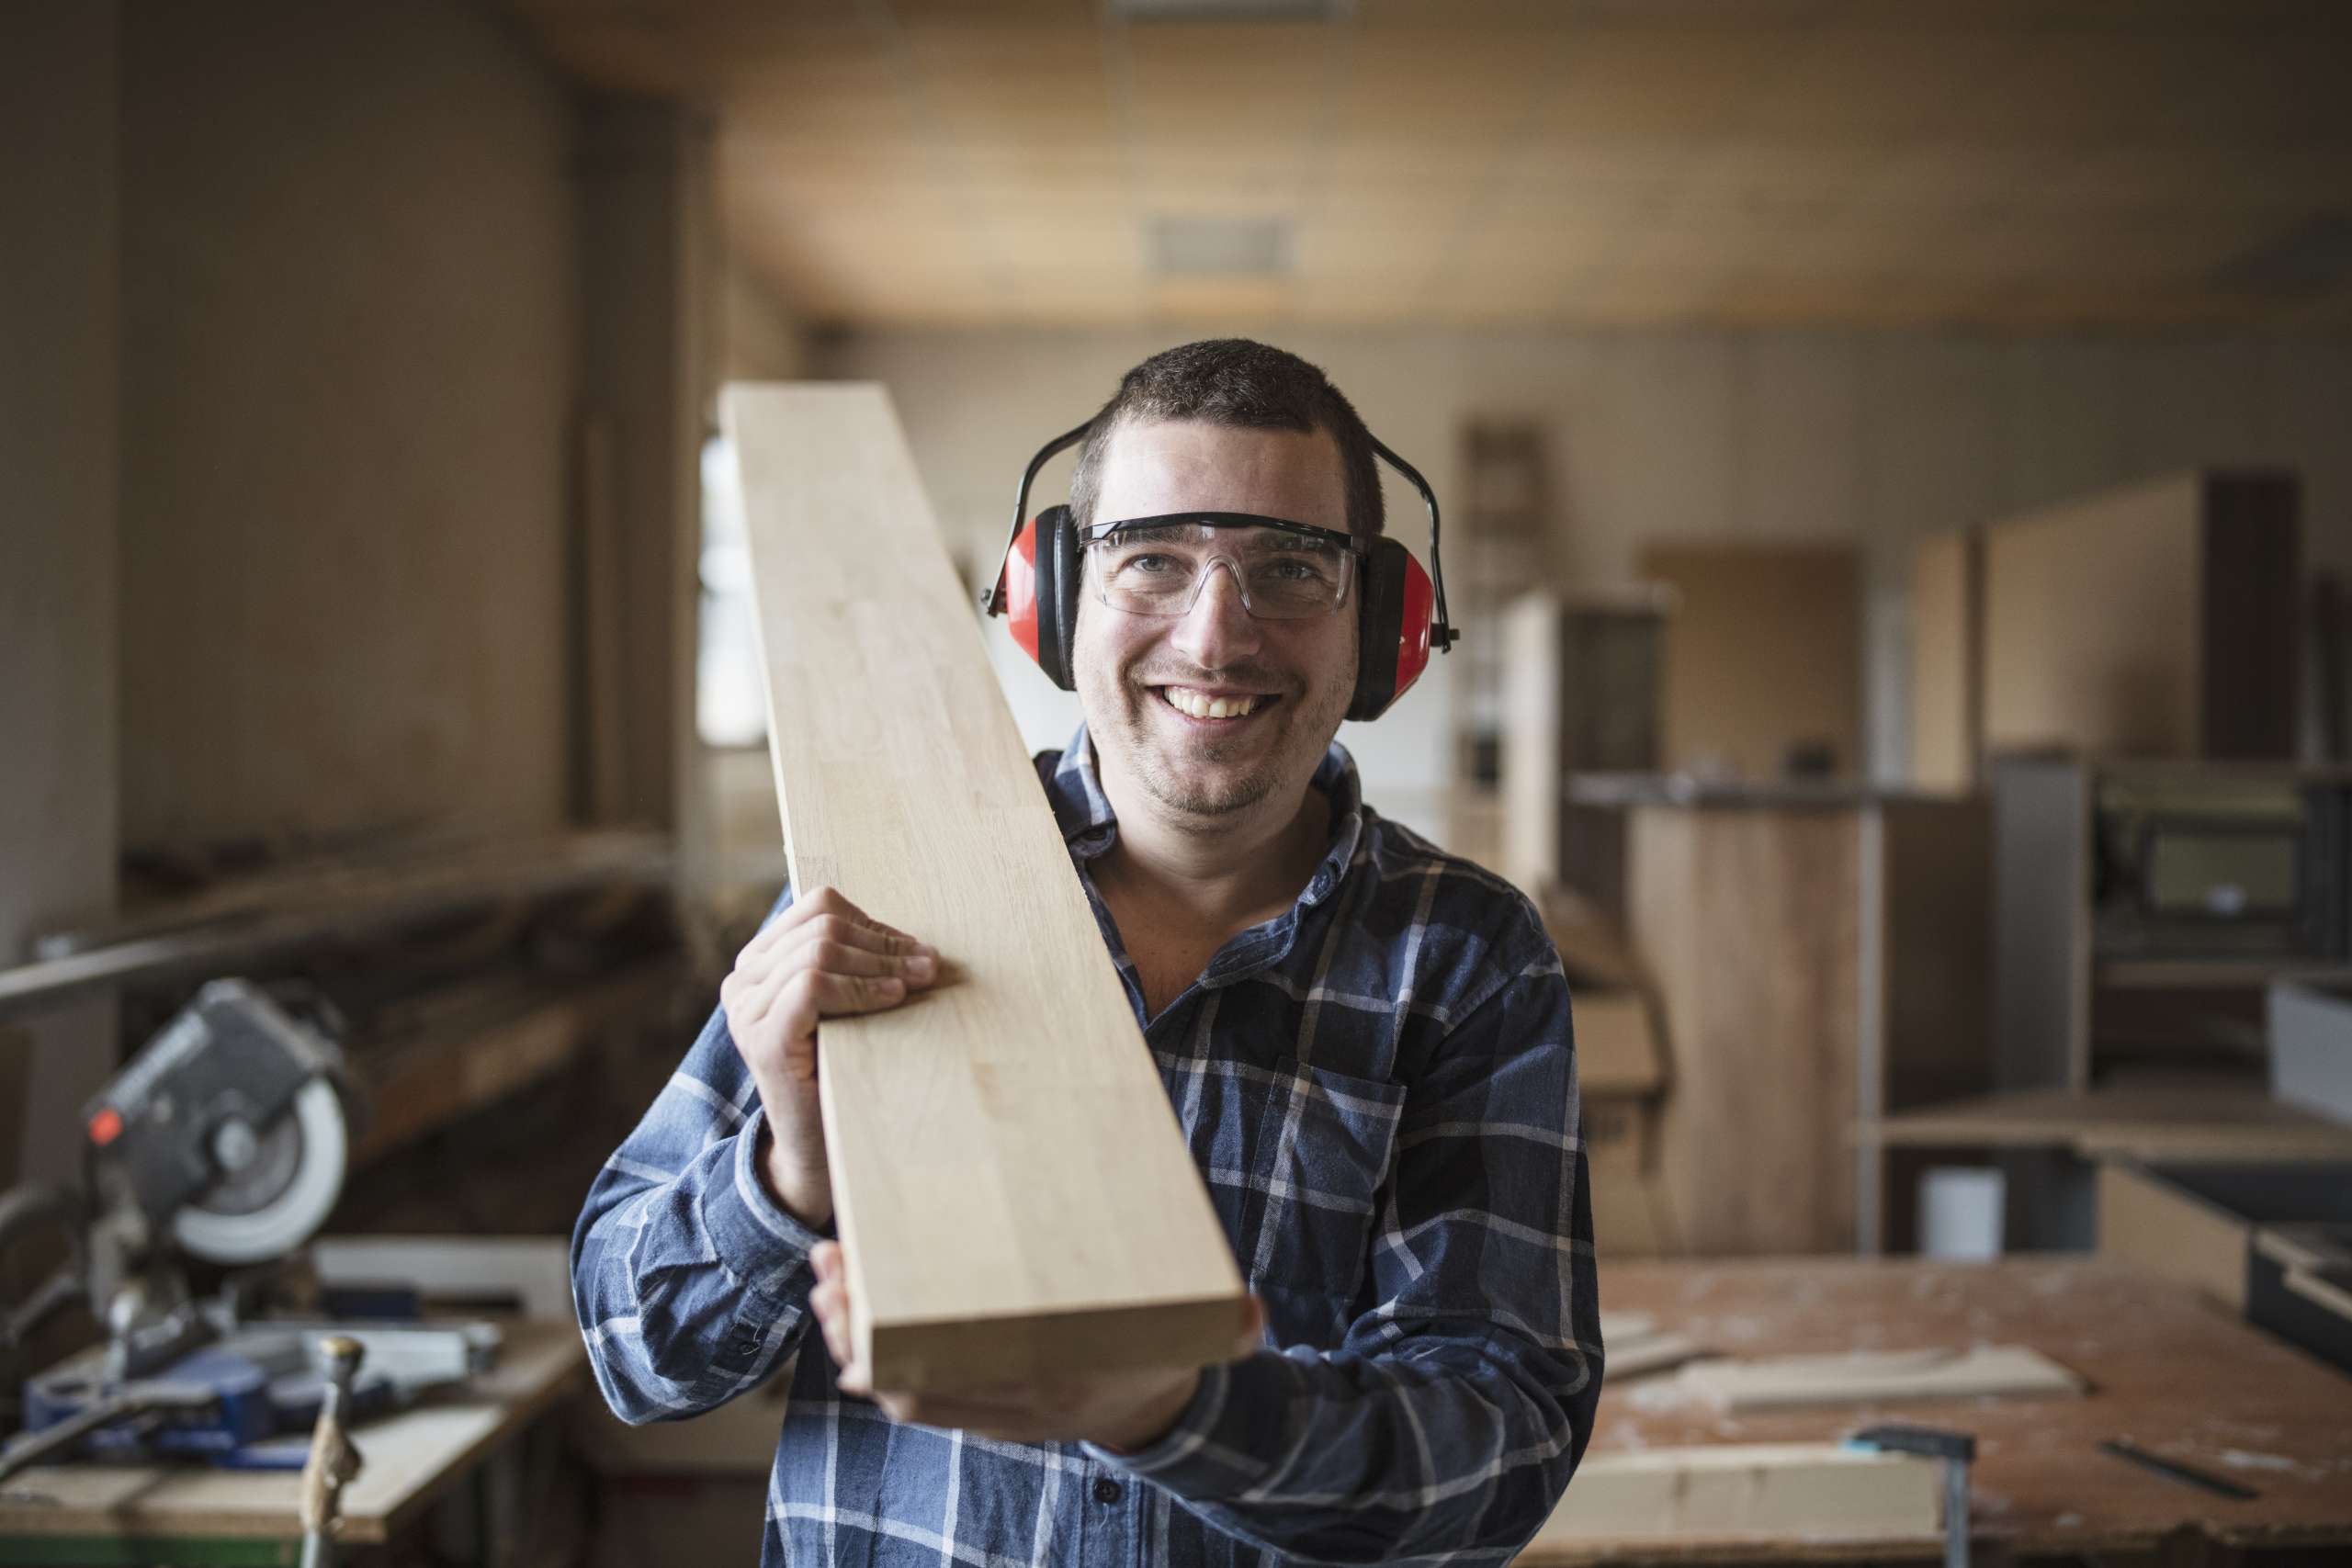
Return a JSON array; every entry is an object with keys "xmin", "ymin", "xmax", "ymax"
[{"xmin": 1574, "ymin": 781, "xmax": 1985, "ymax": 1256}]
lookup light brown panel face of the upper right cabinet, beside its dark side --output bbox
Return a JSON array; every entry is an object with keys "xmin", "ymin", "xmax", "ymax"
[{"xmin": 1985, "ymin": 475, "xmax": 2204, "ymax": 757}]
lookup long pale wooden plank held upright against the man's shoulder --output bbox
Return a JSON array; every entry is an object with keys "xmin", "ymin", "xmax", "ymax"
[{"xmin": 724, "ymin": 383, "xmax": 1244, "ymax": 1389}]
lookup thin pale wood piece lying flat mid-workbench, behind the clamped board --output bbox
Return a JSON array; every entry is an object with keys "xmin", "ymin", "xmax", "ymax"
[{"xmin": 1681, "ymin": 1345, "xmax": 2082, "ymax": 1416}]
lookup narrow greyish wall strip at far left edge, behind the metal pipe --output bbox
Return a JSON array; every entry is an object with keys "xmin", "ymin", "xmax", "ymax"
[{"xmin": 0, "ymin": 0, "xmax": 118, "ymax": 1187}]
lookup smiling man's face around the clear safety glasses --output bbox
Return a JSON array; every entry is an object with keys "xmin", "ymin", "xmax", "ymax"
[{"xmin": 1072, "ymin": 421, "xmax": 1362, "ymax": 818}]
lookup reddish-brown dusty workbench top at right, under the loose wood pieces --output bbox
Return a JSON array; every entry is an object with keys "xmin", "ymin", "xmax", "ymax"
[{"xmin": 1520, "ymin": 1256, "xmax": 2352, "ymax": 1568}]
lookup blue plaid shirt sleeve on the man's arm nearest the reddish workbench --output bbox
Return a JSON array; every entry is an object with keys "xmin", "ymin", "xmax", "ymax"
[{"xmin": 1093, "ymin": 941, "xmax": 1601, "ymax": 1563}]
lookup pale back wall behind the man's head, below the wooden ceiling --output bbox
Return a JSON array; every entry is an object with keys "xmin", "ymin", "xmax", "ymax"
[{"xmin": 819, "ymin": 327, "xmax": 2352, "ymax": 804}]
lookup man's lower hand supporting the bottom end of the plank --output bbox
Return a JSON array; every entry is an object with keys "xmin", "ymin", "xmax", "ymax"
[{"xmin": 809, "ymin": 1241, "xmax": 1265, "ymax": 1453}]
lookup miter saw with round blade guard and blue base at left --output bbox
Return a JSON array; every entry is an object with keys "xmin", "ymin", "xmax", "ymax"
[{"xmin": 0, "ymin": 980, "xmax": 499, "ymax": 1479}]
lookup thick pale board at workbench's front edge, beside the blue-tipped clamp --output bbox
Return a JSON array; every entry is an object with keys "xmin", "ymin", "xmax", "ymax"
[{"xmin": 1529, "ymin": 1443, "xmax": 1943, "ymax": 1556}]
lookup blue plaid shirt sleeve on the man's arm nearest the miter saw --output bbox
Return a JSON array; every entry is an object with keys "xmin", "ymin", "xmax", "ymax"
[{"xmin": 571, "ymin": 891, "xmax": 823, "ymax": 1425}]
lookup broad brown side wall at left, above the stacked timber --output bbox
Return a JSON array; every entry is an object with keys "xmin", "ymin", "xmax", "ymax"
[{"xmin": 119, "ymin": 0, "xmax": 576, "ymax": 846}]
